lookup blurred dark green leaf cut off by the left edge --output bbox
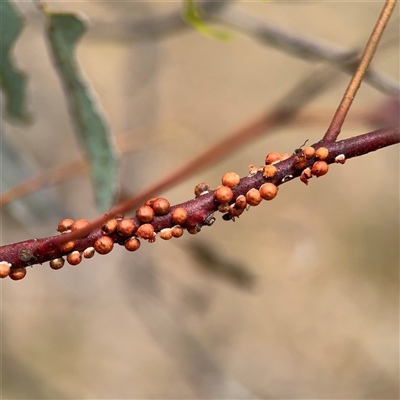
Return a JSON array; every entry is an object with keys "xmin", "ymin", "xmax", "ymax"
[{"xmin": 0, "ymin": 0, "xmax": 31, "ymax": 123}]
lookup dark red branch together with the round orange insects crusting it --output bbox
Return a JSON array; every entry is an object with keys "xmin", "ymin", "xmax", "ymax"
[{"xmin": 0, "ymin": 127, "xmax": 400, "ymax": 279}]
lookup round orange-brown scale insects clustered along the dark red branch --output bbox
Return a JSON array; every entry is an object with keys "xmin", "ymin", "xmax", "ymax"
[{"xmin": 0, "ymin": 145, "xmax": 346, "ymax": 280}]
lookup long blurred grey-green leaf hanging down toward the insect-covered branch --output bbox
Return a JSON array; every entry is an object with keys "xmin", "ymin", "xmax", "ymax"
[{"xmin": 44, "ymin": 9, "xmax": 119, "ymax": 211}]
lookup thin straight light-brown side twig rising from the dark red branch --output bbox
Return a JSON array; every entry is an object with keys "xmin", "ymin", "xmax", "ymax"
[{"xmin": 324, "ymin": 0, "xmax": 397, "ymax": 142}]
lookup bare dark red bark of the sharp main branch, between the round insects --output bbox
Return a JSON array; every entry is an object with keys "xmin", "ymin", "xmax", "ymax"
[{"xmin": 0, "ymin": 127, "xmax": 400, "ymax": 268}]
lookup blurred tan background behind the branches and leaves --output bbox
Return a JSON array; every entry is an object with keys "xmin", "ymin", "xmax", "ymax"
[{"xmin": 1, "ymin": 1, "xmax": 399, "ymax": 399}]
